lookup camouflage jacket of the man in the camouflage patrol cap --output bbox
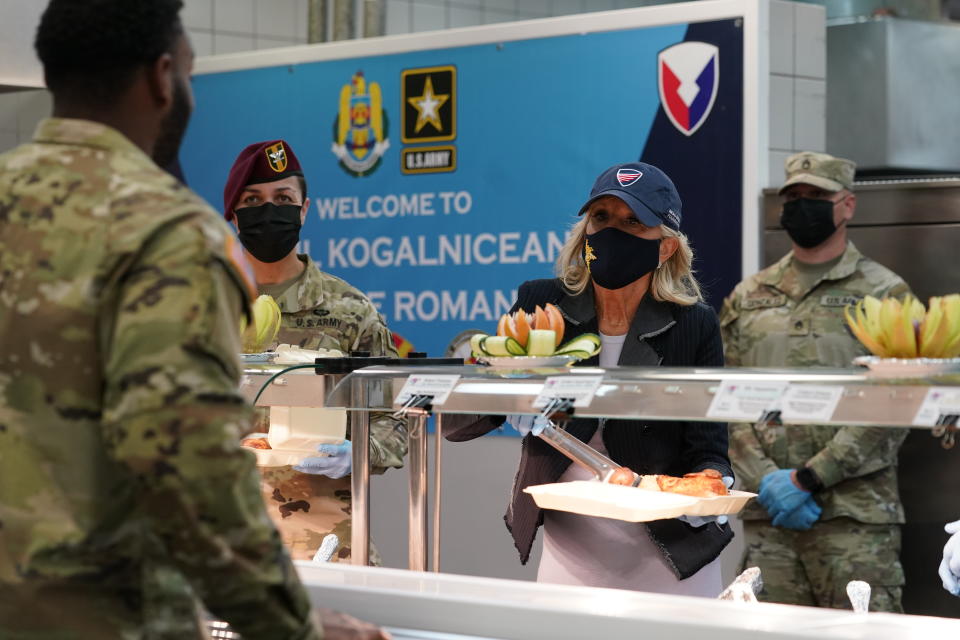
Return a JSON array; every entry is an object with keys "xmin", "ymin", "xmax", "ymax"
[{"xmin": 720, "ymin": 243, "xmax": 909, "ymax": 524}]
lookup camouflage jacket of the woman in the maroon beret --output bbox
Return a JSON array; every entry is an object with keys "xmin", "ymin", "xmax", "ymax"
[{"xmin": 255, "ymin": 255, "xmax": 407, "ymax": 564}]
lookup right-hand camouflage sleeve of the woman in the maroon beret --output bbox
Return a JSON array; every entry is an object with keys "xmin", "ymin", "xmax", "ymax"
[{"xmin": 357, "ymin": 303, "xmax": 407, "ymax": 473}]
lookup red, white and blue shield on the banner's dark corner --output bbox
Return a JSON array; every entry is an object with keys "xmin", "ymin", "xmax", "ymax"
[{"xmin": 657, "ymin": 42, "xmax": 720, "ymax": 136}]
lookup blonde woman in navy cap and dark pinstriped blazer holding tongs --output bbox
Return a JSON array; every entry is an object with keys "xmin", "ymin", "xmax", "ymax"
[{"xmin": 447, "ymin": 162, "xmax": 733, "ymax": 597}]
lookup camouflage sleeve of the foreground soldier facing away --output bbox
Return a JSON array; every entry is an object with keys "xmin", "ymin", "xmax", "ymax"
[{"xmin": 101, "ymin": 219, "xmax": 322, "ymax": 640}]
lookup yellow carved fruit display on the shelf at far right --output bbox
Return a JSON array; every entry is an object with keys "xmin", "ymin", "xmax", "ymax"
[{"xmin": 843, "ymin": 294, "xmax": 960, "ymax": 358}]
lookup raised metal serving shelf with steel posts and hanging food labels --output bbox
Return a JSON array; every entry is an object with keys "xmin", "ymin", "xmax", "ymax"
[{"xmin": 243, "ymin": 366, "xmax": 960, "ymax": 571}]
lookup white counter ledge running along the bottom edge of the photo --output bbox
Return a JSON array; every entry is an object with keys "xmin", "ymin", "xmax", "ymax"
[{"xmin": 297, "ymin": 562, "xmax": 960, "ymax": 640}]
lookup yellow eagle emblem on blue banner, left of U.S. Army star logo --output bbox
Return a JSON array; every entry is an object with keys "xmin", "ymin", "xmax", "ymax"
[{"xmin": 331, "ymin": 71, "xmax": 390, "ymax": 176}]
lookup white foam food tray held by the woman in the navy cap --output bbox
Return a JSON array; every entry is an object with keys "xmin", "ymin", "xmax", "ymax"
[{"xmin": 524, "ymin": 480, "xmax": 757, "ymax": 522}]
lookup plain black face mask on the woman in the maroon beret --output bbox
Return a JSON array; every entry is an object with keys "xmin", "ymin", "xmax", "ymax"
[{"xmin": 235, "ymin": 202, "xmax": 300, "ymax": 262}]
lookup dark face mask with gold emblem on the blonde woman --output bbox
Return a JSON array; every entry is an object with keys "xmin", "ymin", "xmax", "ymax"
[{"xmin": 583, "ymin": 227, "xmax": 660, "ymax": 289}]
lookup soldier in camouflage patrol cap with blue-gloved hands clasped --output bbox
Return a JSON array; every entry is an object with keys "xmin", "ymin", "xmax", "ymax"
[{"xmin": 720, "ymin": 153, "xmax": 909, "ymax": 611}]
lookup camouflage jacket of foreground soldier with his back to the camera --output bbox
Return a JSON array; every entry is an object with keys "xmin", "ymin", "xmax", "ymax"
[{"xmin": 0, "ymin": 119, "xmax": 321, "ymax": 640}]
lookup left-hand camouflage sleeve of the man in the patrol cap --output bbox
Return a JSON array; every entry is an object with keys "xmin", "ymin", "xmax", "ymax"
[{"xmin": 720, "ymin": 286, "xmax": 779, "ymax": 492}]
